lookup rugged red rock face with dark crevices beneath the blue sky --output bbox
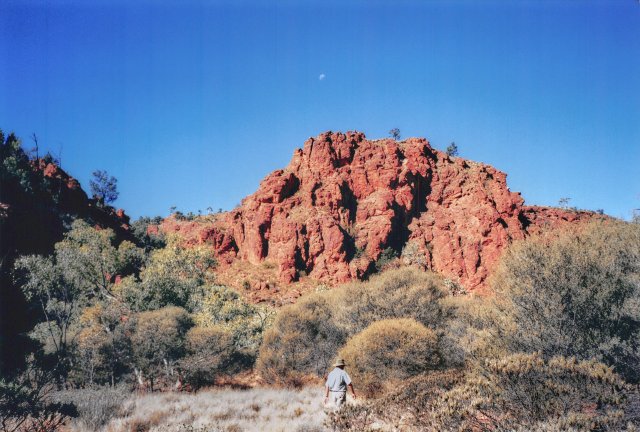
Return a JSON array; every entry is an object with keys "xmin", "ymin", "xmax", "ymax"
[{"xmin": 163, "ymin": 132, "xmax": 592, "ymax": 289}]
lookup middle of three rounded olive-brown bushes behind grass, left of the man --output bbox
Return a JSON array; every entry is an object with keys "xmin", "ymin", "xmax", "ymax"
[{"xmin": 131, "ymin": 306, "xmax": 193, "ymax": 390}]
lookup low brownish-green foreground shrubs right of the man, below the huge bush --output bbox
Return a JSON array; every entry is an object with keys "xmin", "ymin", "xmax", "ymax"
[{"xmin": 336, "ymin": 353, "xmax": 635, "ymax": 432}]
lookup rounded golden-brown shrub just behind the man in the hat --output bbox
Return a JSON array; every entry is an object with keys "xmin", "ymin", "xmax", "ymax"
[{"xmin": 340, "ymin": 318, "xmax": 440, "ymax": 395}]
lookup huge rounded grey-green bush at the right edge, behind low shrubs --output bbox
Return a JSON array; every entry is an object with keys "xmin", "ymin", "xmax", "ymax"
[{"xmin": 472, "ymin": 220, "xmax": 640, "ymax": 382}]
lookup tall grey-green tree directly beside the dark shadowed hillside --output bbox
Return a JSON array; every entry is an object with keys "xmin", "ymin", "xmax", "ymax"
[{"xmin": 16, "ymin": 220, "xmax": 141, "ymax": 375}]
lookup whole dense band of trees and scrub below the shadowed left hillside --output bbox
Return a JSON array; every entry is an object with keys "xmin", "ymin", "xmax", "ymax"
[{"xmin": 0, "ymin": 213, "xmax": 271, "ymax": 430}]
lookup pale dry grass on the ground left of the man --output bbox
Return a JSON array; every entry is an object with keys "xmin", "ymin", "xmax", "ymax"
[{"xmin": 76, "ymin": 387, "xmax": 326, "ymax": 432}]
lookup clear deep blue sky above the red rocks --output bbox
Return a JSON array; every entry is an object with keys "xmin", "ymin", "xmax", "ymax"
[{"xmin": 0, "ymin": 0, "xmax": 640, "ymax": 218}]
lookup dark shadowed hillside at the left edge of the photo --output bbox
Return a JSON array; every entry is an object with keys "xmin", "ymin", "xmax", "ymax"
[{"xmin": 0, "ymin": 135, "xmax": 132, "ymax": 371}]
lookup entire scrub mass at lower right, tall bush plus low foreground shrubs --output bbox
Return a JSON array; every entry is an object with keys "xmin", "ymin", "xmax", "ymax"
[{"xmin": 329, "ymin": 220, "xmax": 640, "ymax": 431}]
